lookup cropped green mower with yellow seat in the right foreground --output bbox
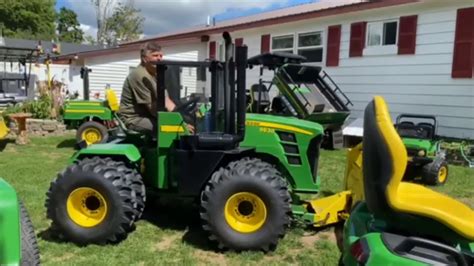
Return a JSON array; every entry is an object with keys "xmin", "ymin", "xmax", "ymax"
[{"xmin": 340, "ymin": 96, "xmax": 474, "ymax": 266}]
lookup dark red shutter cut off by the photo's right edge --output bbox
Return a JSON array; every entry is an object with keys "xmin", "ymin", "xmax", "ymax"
[{"xmin": 451, "ymin": 7, "xmax": 474, "ymax": 78}]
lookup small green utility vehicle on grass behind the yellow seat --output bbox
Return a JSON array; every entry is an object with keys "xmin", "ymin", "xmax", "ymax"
[{"xmin": 396, "ymin": 114, "xmax": 448, "ymax": 185}]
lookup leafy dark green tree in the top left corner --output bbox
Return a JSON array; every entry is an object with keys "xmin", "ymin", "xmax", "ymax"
[{"xmin": 0, "ymin": 0, "xmax": 56, "ymax": 40}]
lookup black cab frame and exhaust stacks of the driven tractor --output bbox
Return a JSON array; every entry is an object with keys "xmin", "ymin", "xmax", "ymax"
[{"xmin": 156, "ymin": 32, "xmax": 247, "ymax": 149}]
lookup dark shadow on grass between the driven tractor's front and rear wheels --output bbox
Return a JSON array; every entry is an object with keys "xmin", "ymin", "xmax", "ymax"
[{"xmin": 142, "ymin": 199, "xmax": 217, "ymax": 251}]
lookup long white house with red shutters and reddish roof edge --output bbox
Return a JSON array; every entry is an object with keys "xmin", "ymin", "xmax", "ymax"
[{"xmin": 53, "ymin": 0, "xmax": 474, "ymax": 139}]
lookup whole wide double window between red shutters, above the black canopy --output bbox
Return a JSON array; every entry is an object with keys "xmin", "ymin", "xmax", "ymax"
[{"xmin": 272, "ymin": 31, "xmax": 323, "ymax": 62}]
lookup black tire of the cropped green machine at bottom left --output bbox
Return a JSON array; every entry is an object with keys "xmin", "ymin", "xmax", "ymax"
[{"xmin": 20, "ymin": 201, "xmax": 40, "ymax": 266}]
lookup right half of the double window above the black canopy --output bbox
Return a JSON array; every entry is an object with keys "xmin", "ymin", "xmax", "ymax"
[{"xmin": 298, "ymin": 32, "xmax": 323, "ymax": 62}]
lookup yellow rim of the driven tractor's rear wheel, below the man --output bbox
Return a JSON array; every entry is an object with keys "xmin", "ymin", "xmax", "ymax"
[{"xmin": 67, "ymin": 187, "xmax": 107, "ymax": 227}]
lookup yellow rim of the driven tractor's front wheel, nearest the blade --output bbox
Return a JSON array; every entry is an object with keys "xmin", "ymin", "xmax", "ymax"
[{"xmin": 224, "ymin": 192, "xmax": 267, "ymax": 233}]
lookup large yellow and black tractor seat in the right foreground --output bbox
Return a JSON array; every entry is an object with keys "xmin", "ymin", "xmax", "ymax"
[{"xmin": 363, "ymin": 96, "xmax": 474, "ymax": 240}]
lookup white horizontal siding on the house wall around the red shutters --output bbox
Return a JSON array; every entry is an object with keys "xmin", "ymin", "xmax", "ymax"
[{"xmin": 206, "ymin": 1, "xmax": 474, "ymax": 139}]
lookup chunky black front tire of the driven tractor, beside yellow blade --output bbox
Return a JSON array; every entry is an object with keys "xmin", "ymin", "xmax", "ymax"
[{"xmin": 200, "ymin": 158, "xmax": 291, "ymax": 252}]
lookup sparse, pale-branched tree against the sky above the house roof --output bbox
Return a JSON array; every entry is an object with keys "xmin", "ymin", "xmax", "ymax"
[{"xmin": 106, "ymin": 1, "xmax": 145, "ymax": 45}]
